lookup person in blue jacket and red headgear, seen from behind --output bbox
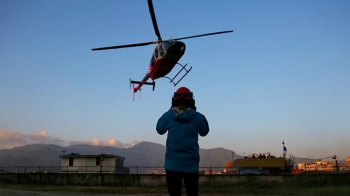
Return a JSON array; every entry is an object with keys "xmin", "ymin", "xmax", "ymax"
[{"xmin": 156, "ymin": 87, "xmax": 209, "ymax": 196}]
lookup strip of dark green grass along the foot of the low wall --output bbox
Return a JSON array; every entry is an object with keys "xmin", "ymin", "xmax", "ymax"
[{"xmin": 0, "ymin": 182, "xmax": 350, "ymax": 196}]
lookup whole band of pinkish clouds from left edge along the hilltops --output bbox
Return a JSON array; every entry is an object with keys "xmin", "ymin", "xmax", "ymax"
[{"xmin": 0, "ymin": 130, "xmax": 142, "ymax": 149}]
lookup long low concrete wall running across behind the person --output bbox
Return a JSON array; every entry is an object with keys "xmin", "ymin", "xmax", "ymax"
[{"xmin": 0, "ymin": 173, "xmax": 350, "ymax": 186}]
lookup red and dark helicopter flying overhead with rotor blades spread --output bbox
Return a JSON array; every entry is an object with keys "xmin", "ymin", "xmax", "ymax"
[{"xmin": 92, "ymin": 0, "xmax": 233, "ymax": 94}]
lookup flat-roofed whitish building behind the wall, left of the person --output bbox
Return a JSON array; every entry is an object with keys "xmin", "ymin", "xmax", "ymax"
[{"xmin": 59, "ymin": 153, "xmax": 130, "ymax": 174}]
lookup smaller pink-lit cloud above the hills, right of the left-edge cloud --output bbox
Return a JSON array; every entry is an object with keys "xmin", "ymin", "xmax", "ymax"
[{"xmin": 70, "ymin": 138, "xmax": 142, "ymax": 148}]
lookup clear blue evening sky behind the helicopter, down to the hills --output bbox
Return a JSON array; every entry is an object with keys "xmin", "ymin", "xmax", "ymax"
[{"xmin": 0, "ymin": 0, "xmax": 350, "ymax": 159}]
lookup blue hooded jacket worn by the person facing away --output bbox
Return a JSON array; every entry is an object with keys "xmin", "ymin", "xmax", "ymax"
[{"xmin": 156, "ymin": 107, "xmax": 209, "ymax": 173}]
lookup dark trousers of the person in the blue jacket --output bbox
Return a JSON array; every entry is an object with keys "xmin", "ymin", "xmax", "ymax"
[{"xmin": 166, "ymin": 170, "xmax": 199, "ymax": 196}]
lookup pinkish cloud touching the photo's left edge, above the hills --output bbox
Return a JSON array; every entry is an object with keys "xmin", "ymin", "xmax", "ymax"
[{"xmin": 0, "ymin": 130, "xmax": 67, "ymax": 149}]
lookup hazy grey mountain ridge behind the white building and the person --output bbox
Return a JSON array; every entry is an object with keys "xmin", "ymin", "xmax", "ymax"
[{"xmin": 0, "ymin": 142, "xmax": 241, "ymax": 167}]
